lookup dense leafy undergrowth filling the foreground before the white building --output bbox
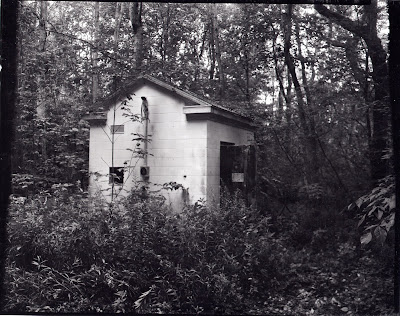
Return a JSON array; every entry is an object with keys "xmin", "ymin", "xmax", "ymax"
[{"xmin": 4, "ymin": 187, "xmax": 391, "ymax": 315}]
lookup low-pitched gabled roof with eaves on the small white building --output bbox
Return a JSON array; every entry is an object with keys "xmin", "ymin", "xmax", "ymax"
[{"xmin": 85, "ymin": 74, "xmax": 255, "ymax": 130}]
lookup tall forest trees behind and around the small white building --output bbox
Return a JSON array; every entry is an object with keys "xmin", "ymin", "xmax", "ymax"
[{"xmin": 13, "ymin": 1, "xmax": 391, "ymax": 200}]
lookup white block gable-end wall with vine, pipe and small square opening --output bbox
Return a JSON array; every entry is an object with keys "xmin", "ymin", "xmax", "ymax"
[{"xmin": 89, "ymin": 85, "xmax": 207, "ymax": 208}]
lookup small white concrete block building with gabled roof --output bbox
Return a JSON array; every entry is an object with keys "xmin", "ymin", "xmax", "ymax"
[{"xmin": 85, "ymin": 75, "xmax": 254, "ymax": 209}]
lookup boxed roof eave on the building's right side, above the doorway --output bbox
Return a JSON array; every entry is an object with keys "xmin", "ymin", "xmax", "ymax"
[{"xmin": 183, "ymin": 106, "xmax": 256, "ymax": 131}]
